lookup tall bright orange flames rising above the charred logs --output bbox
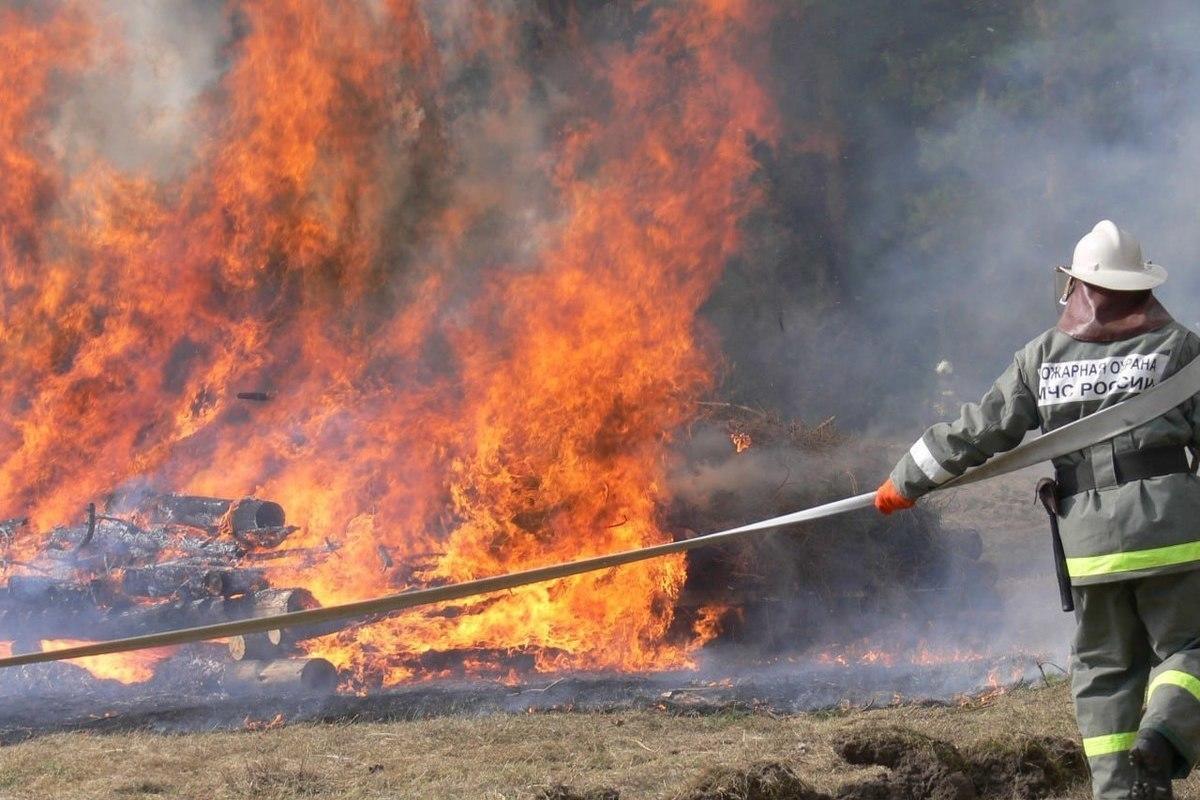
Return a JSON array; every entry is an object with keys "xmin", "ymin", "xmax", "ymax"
[{"xmin": 0, "ymin": 0, "xmax": 775, "ymax": 685}]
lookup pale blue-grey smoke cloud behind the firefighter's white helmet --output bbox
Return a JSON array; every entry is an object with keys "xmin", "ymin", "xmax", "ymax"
[{"xmin": 851, "ymin": 0, "xmax": 1200, "ymax": 435}]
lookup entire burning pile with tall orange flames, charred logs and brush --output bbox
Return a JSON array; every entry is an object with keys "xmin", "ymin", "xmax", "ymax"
[{"xmin": 0, "ymin": 0, "xmax": 1041, "ymax": 724}]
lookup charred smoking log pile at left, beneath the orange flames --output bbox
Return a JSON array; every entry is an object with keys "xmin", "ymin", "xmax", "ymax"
[{"xmin": 0, "ymin": 494, "xmax": 337, "ymax": 691}]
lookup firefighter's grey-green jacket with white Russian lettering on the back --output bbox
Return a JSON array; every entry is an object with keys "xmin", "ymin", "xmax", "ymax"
[{"xmin": 892, "ymin": 321, "xmax": 1200, "ymax": 585}]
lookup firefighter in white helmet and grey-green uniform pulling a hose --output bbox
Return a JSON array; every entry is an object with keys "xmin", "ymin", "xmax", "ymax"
[{"xmin": 875, "ymin": 221, "xmax": 1200, "ymax": 800}]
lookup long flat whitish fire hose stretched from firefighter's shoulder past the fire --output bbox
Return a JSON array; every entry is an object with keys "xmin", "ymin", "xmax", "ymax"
[{"xmin": 0, "ymin": 359, "xmax": 1200, "ymax": 667}]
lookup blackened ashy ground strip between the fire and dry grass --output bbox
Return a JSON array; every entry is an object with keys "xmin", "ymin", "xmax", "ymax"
[{"xmin": 0, "ymin": 652, "xmax": 1045, "ymax": 744}]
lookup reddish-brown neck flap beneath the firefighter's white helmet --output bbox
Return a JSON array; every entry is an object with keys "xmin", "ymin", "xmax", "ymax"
[{"xmin": 1058, "ymin": 281, "xmax": 1171, "ymax": 342}]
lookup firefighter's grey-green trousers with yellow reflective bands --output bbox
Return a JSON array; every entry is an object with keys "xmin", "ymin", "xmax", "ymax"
[{"xmin": 1072, "ymin": 570, "xmax": 1200, "ymax": 800}]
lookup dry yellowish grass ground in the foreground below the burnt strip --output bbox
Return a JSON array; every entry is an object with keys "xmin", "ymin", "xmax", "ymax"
[{"xmin": 0, "ymin": 684, "xmax": 1200, "ymax": 800}]
